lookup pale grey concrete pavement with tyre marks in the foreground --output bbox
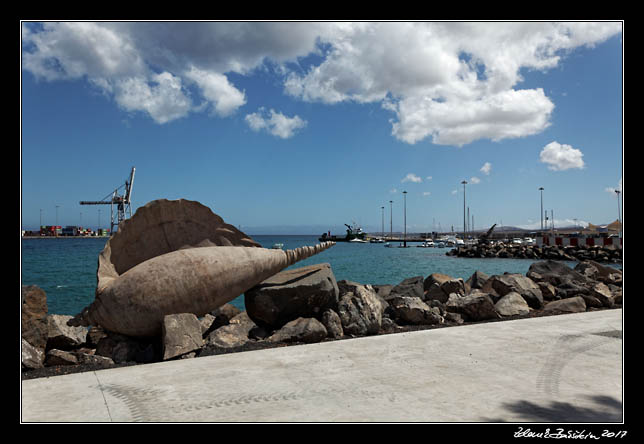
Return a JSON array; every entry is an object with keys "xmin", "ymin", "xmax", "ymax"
[{"xmin": 21, "ymin": 309, "xmax": 623, "ymax": 423}]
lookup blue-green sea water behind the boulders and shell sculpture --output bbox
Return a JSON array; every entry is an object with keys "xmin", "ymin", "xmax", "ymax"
[{"xmin": 21, "ymin": 235, "xmax": 576, "ymax": 315}]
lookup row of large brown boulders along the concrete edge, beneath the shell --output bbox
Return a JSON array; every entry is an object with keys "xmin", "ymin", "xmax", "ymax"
[{"xmin": 22, "ymin": 260, "xmax": 623, "ymax": 379}]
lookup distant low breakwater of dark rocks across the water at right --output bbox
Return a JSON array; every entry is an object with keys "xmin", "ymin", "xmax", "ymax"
[{"xmin": 446, "ymin": 244, "xmax": 622, "ymax": 263}]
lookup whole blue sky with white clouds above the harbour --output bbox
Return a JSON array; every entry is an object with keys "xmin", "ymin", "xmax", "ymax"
[{"xmin": 21, "ymin": 22, "xmax": 623, "ymax": 234}]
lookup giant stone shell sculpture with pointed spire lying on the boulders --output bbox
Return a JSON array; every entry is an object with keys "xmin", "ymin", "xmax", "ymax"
[{"xmin": 69, "ymin": 199, "xmax": 335, "ymax": 336}]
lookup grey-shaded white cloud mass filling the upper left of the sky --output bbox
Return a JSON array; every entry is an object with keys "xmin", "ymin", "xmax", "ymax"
[{"xmin": 22, "ymin": 22, "xmax": 323, "ymax": 124}]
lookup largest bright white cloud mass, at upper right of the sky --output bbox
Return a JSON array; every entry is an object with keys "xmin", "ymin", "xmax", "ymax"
[{"xmin": 285, "ymin": 22, "xmax": 621, "ymax": 146}]
